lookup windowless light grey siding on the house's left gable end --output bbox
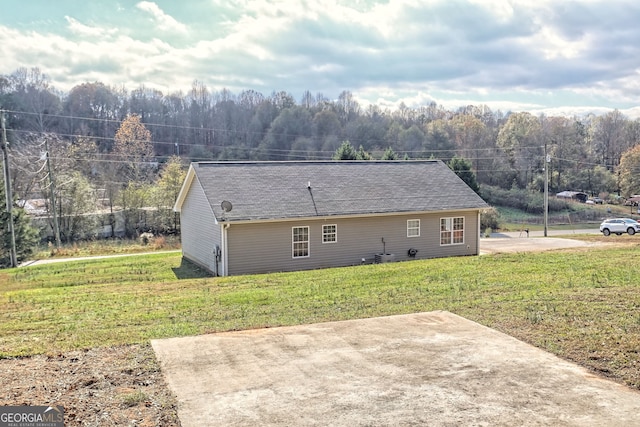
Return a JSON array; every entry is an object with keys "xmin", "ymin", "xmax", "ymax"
[{"xmin": 180, "ymin": 178, "xmax": 221, "ymax": 273}]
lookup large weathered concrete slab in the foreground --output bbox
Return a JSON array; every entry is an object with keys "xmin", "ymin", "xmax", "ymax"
[{"xmin": 152, "ymin": 311, "xmax": 640, "ymax": 427}]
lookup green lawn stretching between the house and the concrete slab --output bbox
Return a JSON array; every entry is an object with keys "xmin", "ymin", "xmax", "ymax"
[{"xmin": 0, "ymin": 241, "xmax": 640, "ymax": 388}]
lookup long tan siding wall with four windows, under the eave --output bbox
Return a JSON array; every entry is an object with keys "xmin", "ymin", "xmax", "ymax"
[{"xmin": 227, "ymin": 210, "xmax": 479, "ymax": 275}]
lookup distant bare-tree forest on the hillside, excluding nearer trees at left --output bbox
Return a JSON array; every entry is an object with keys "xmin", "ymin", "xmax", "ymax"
[{"xmin": 0, "ymin": 69, "xmax": 640, "ymax": 194}]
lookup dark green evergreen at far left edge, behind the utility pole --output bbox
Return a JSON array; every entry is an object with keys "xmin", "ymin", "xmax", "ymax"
[{"xmin": 0, "ymin": 177, "xmax": 38, "ymax": 268}]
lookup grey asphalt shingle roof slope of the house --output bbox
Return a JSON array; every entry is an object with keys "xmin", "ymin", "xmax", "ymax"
[{"xmin": 192, "ymin": 160, "xmax": 487, "ymax": 221}]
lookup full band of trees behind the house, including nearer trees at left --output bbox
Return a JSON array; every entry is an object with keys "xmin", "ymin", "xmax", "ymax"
[{"xmin": 0, "ymin": 68, "xmax": 640, "ymax": 266}]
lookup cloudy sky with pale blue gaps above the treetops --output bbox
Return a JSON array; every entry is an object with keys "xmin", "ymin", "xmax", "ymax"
[{"xmin": 0, "ymin": 0, "xmax": 640, "ymax": 117}]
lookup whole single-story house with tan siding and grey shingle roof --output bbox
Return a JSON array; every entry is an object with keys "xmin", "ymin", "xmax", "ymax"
[{"xmin": 174, "ymin": 160, "xmax": 488, "ymax": 276}]
